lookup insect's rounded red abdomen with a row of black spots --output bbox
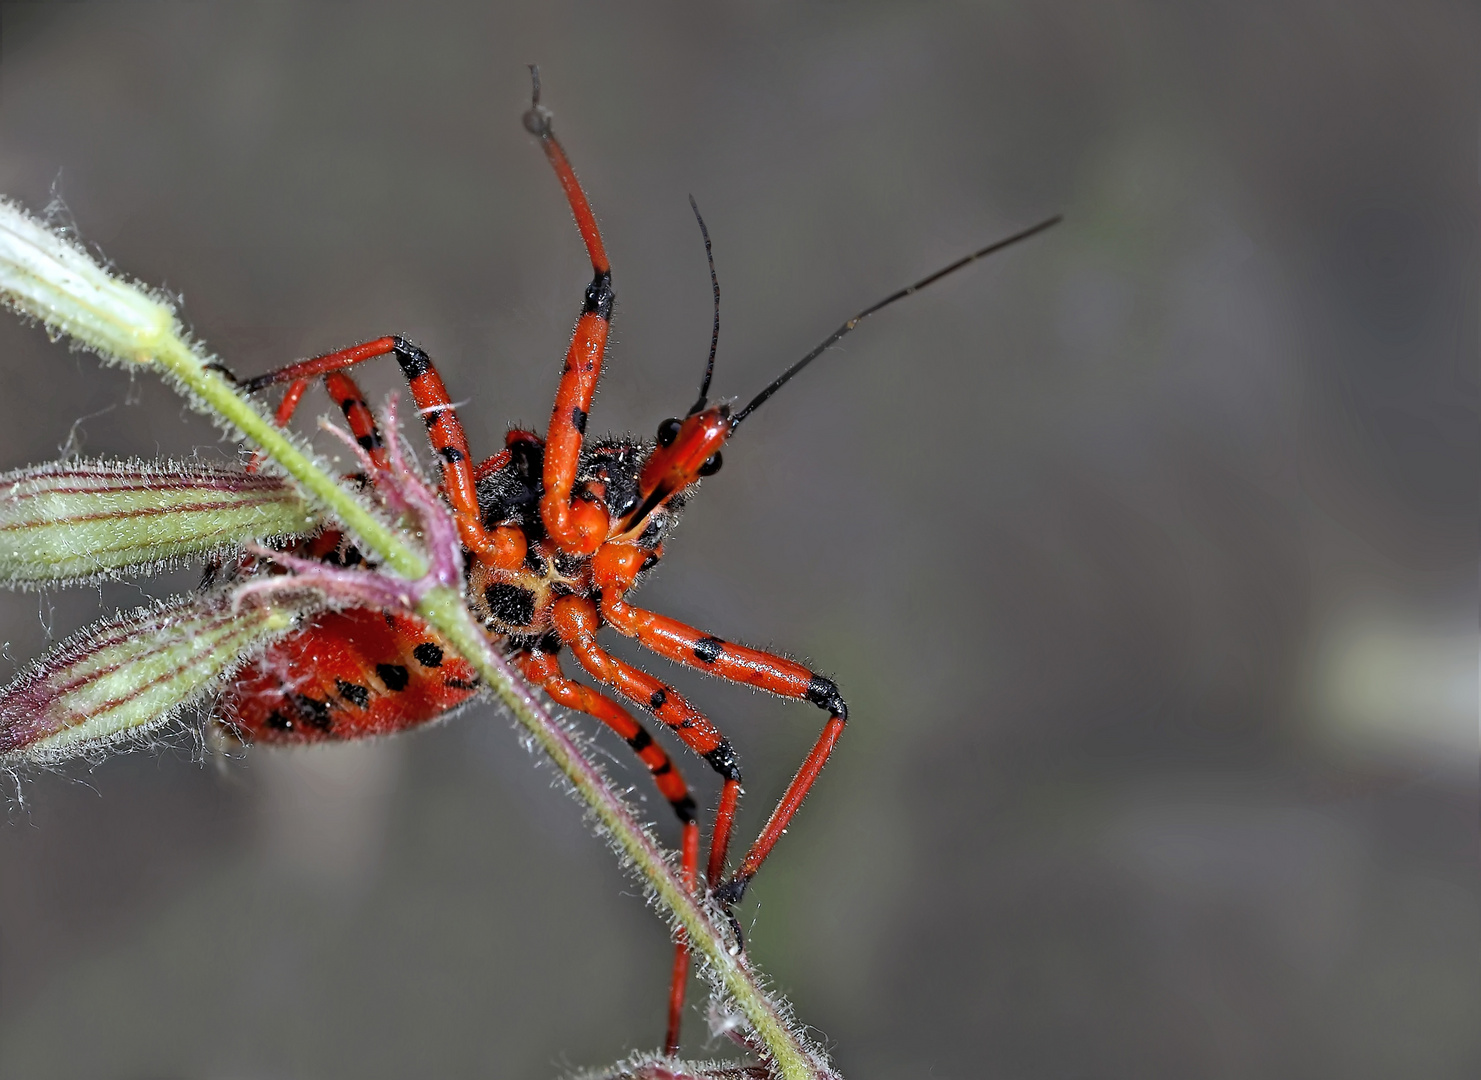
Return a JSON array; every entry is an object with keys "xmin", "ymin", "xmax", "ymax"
[{"xmin": 216, "ymin": 607, "xmax": 478, "ymax": 742}]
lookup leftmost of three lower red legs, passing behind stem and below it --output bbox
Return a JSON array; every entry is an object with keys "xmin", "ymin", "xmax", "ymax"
[{"xmin": 515, "ymin": 652, "xmax": 699, "ymax": 1055}]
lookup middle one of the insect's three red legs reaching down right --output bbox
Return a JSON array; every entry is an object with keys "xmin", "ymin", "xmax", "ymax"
[{"xmin": 551, "ymin": 596, "xmax": 741, "ymax": 887}]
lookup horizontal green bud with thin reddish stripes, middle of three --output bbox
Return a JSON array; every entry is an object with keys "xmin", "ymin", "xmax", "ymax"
[{"xmin": 0, "ymin": 461, "xmax": 318, "ymax": 585}]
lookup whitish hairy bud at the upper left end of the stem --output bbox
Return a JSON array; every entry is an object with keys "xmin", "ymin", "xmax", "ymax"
[{"xmin": 0, "ymin": 200, "xmax": 176, "ymax": 363}]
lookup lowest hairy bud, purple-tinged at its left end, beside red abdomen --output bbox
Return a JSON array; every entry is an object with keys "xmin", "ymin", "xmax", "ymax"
[{"xmin": 0, "ymin": 590, "xmax": 317, "ymax": 764}]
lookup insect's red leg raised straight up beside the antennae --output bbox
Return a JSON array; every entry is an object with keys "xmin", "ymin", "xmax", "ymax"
[{"xmin": 524, "ymin": 93, "xmax": 613, "ymax": 556}]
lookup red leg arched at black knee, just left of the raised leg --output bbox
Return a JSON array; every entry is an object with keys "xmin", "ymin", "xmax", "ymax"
[{"xmin": 244, "ymin": 336, "xmax": 526, "ymax": 570}]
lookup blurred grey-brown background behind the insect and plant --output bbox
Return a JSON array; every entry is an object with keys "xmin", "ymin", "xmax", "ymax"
[{"xmin": 0, "ymin": 0, "xmax": 1481, "ymax": 1080}]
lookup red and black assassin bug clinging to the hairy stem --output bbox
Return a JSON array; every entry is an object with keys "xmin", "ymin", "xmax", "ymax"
[{"xmin": 218, "ymin": 74, "xmax": 1057, "ymax": 1052}]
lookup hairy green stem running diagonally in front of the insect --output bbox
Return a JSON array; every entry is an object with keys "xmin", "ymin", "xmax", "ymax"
[{"xmin": 156, "ymin": 335, "xmax": 831, "ymax": 1080}]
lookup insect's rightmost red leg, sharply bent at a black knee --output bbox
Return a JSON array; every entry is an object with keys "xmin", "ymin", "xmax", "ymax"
[{"xmin": 601, "ymin": 593, "xmax": 849, "ymax": 904}]
